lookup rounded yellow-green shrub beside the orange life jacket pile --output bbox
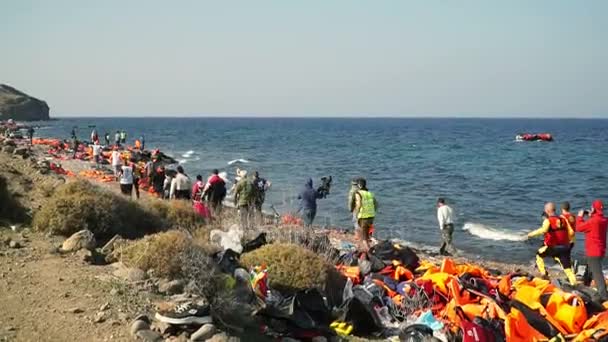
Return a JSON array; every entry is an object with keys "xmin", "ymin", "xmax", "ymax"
[{"xmin": 241, "ymin": 243, "xmax": 331, "ymax": 292}]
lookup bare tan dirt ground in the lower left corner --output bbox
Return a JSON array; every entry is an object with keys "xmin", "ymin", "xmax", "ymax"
[{"xmin": 0, "ymin": 229, "xmax": 157, "ymax": 341}]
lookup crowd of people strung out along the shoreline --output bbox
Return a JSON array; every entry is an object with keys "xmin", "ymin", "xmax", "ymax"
[{"xmin": 73, "ymin": 129, "xmax": 608, "ymax": 299}]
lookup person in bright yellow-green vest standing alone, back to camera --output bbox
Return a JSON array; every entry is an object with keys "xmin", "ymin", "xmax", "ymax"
[{"xmin": 354, "ymin": 178, "xmax": 378, "ymax": 252}]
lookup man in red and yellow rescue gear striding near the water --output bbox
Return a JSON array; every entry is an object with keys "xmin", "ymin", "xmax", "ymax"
[{"xmin": 528, "ymin": 202, "xmax": 576, "ymax": 285}]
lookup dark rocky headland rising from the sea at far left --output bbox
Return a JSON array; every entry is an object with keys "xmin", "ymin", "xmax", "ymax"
[{"xmin": 0, "ymin": 84, "xmax": 49, "ymax": 121}]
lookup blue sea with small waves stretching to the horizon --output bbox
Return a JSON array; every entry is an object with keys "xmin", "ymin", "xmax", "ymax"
[{"xmin": 30, "ymin": 117, "xmax": 608, "ymax": 264}]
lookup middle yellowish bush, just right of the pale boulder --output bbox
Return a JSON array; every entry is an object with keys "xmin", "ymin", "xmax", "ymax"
[{"xmin": 115, "ymin": 230, "xmax": 192, "ymax": 278}]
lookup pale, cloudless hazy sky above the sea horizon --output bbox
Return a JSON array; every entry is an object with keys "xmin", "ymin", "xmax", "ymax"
[{"xmin": 0, "ymin": 0, "xmax": 608, "ymax": 117}]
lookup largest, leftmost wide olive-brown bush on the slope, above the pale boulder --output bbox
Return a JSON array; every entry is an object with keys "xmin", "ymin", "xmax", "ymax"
[{"xmin": 33, "ymin": 180, "xmax": 163, "ymax": 240}]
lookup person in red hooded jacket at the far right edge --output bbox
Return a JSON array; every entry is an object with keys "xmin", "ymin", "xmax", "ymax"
[{"xmin": 576, "ymin": 200, "xmax": 608, "ymax": 301}]
